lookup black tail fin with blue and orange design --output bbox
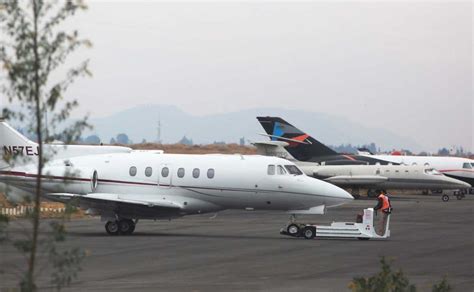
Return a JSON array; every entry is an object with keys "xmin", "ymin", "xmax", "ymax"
[{"xmin": 257, "ymin": 117, "xmax": 338, "ymax": 161}]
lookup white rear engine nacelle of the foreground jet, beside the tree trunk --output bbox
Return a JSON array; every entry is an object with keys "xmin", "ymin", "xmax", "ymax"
[{"xmin": 42, "ymin": 166, "xmax": 99, "ymax": 194}]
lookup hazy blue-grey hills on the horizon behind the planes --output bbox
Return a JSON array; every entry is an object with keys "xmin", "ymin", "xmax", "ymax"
[{"xmin": 86, "ymin": 105, "xmax": 421, "ymax": 151}]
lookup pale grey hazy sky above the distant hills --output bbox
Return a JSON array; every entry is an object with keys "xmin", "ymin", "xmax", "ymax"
[{"xmin": 1, "ymin": 1, "xmax": 474, "ymax": 150}]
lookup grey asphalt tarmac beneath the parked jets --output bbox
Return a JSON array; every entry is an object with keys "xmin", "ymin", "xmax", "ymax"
[{"xmin": 0, "ymin": 195, "xmax": 474, "ymax": 291}]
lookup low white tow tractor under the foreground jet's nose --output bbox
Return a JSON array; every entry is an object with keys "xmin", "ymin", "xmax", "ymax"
[{"xmin": 280, "ymin": 208, "xmax": 391, "ymax": 240}]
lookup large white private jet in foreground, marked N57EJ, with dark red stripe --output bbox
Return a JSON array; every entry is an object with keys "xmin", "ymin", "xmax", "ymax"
[{"xmin": 0, "ymin": 122, "xmax": 353, "ymax": 235}]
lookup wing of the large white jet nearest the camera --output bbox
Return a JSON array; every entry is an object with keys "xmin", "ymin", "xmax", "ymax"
[{"xmin": 45, "ymin": 193, "xmax": 182, "ymax": 218}]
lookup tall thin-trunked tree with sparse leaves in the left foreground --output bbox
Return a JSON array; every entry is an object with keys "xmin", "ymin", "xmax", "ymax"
[{"xmin": 0, "ymin": 0, "xmax": 90, "ymax": 291}]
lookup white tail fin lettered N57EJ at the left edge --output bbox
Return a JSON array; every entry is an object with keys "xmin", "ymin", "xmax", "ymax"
[{"xmin": 0, "ymin": 119, "xmax": 39, "ymax": 168}]
